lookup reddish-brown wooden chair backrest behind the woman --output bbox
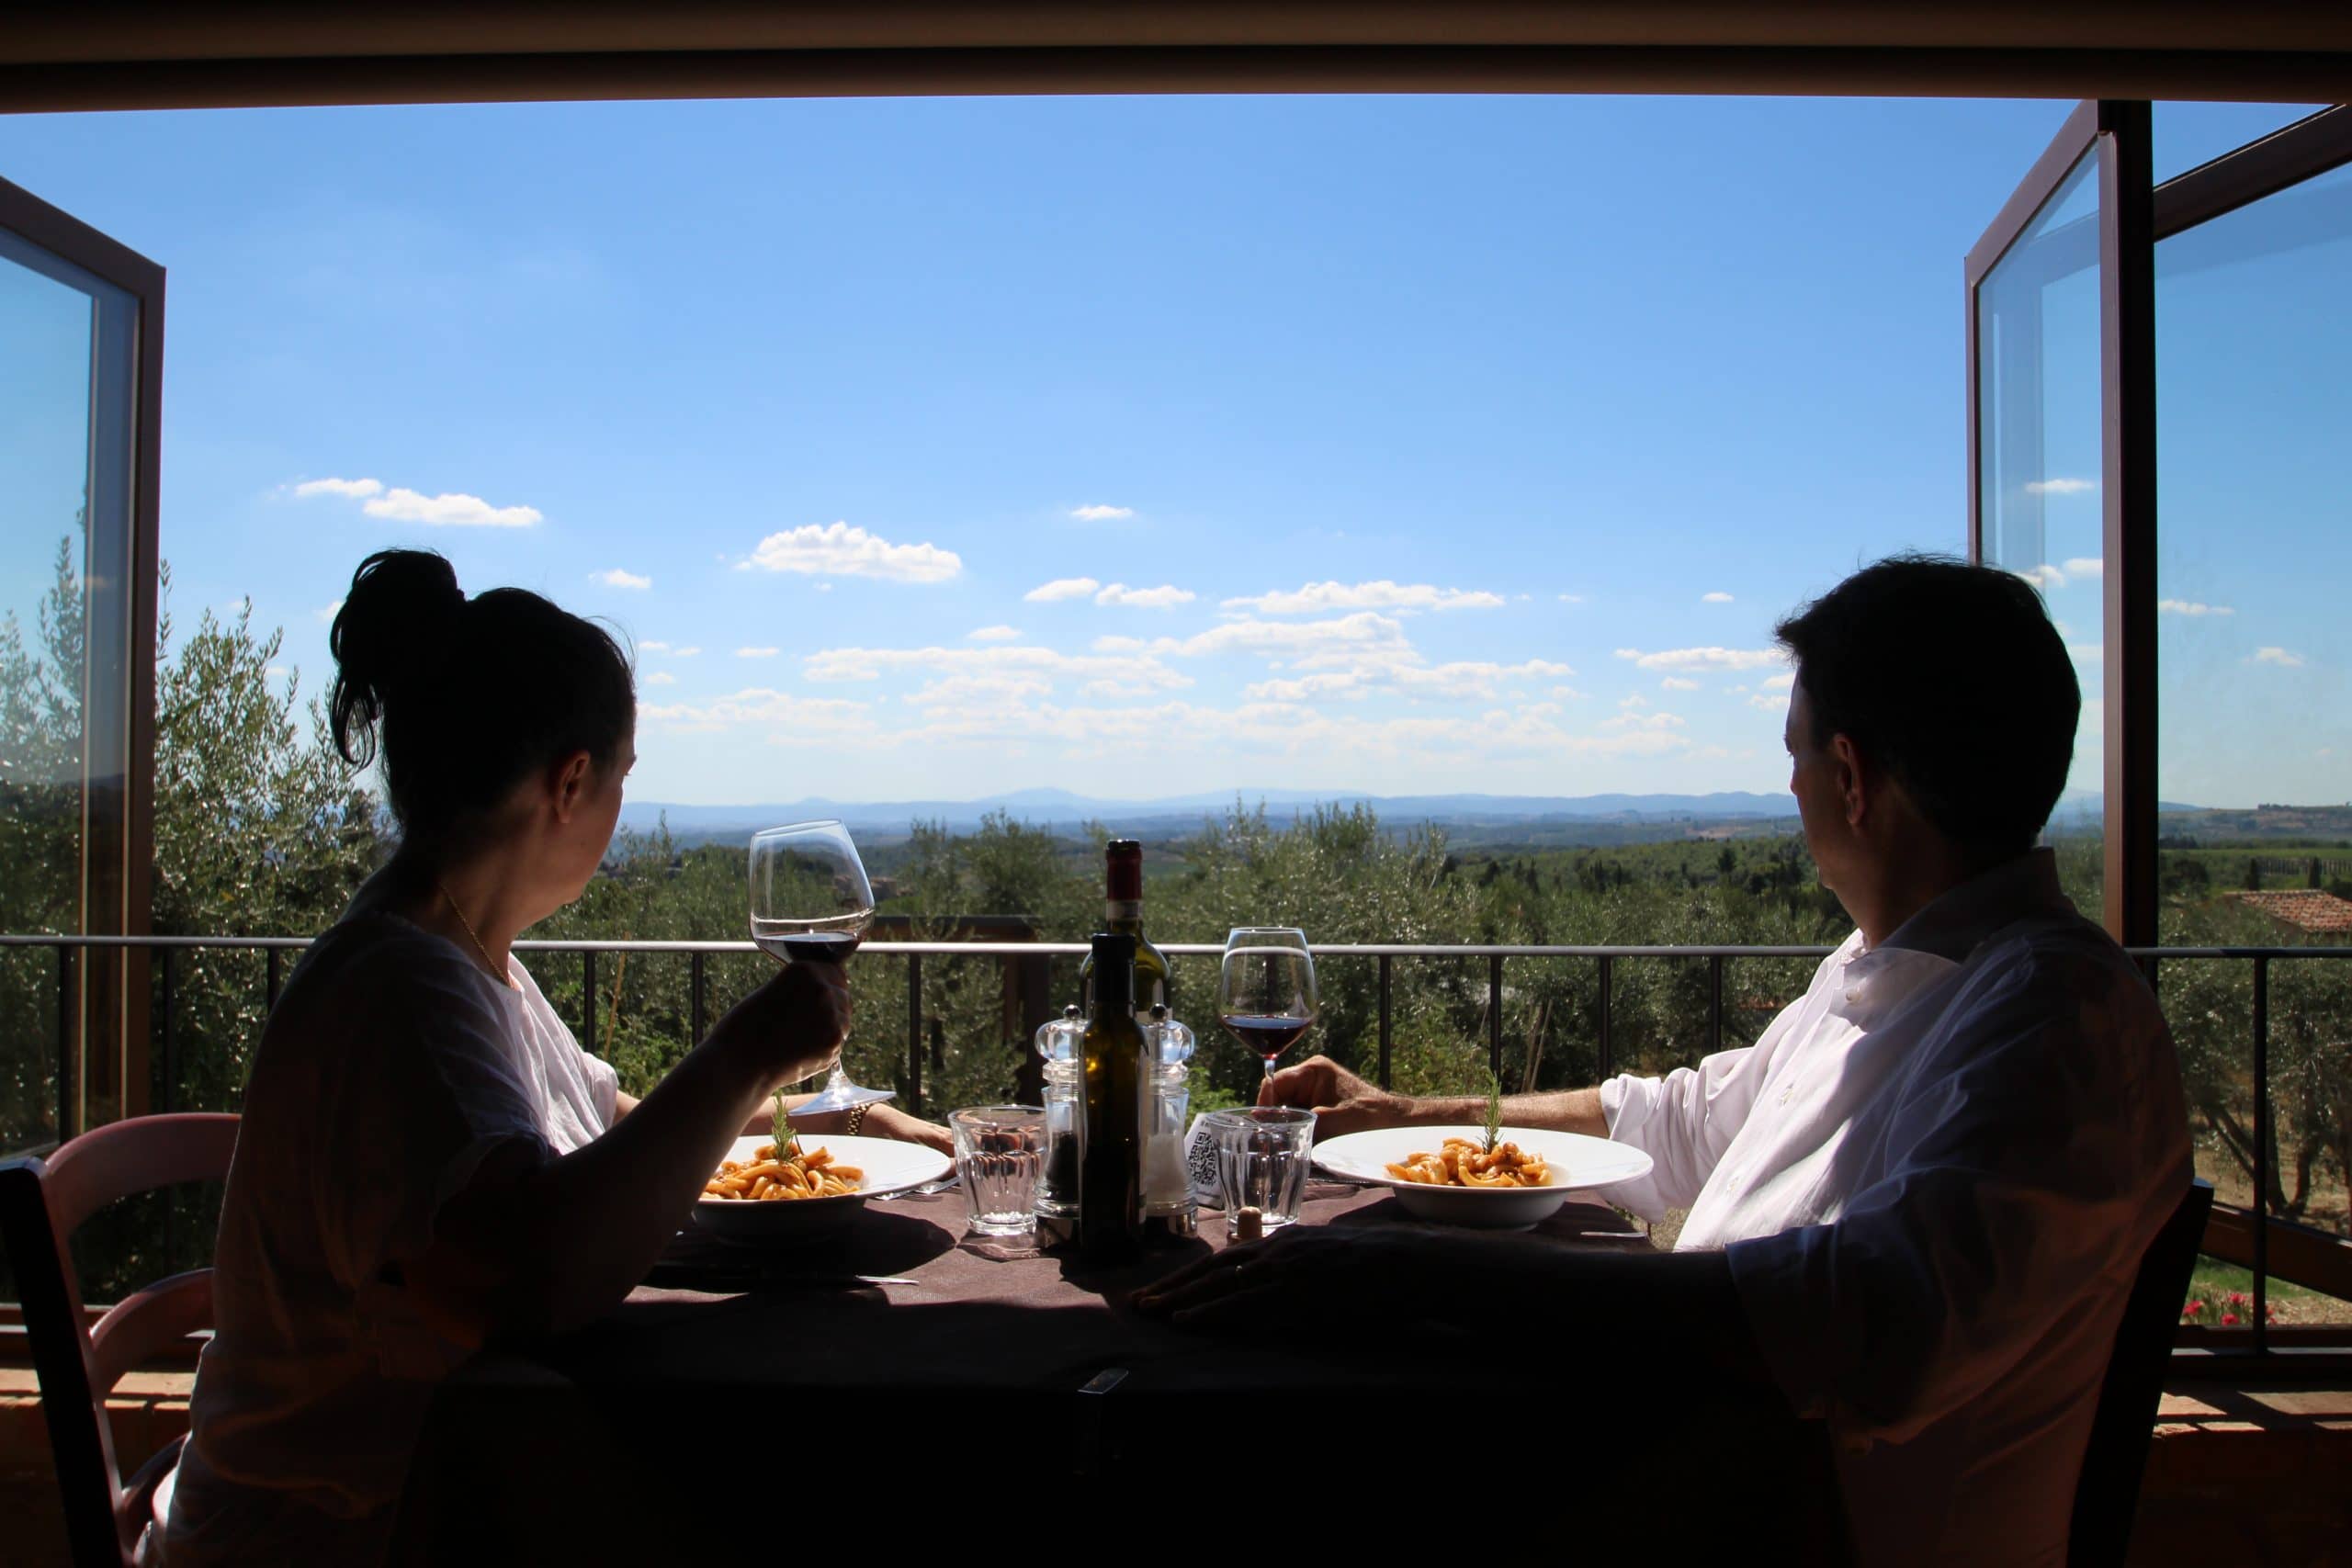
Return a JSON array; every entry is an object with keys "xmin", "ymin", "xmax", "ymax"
[{"xmin": 0, "ymin": 1112, "xmax": 238, "ymax": 1568}]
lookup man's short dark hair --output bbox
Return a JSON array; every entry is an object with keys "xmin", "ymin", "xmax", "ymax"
[{"xmin": 1773, "ymin": 555, "xmax": 2082, "ymax": 863}]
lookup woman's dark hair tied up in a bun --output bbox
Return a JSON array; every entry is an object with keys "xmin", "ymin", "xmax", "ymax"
[{"xmin": 327, "ymin": 550, "xmax": 638, "ymax": 840}]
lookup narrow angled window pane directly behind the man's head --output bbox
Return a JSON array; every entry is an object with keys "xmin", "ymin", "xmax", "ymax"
[{"xmin": 1975, "ymin": 155, "xmax": 2103, "ymax": 919}]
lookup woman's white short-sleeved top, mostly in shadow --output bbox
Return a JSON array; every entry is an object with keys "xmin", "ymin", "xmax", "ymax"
[{"xmin": 143, "ymin": 915, "xmax": 618, "ymax": 1568}]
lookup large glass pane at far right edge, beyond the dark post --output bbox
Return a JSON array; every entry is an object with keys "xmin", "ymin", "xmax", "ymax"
[{"xmin": 2157, "ymin": 169, "xmax": 2352, "ymax": 1321}]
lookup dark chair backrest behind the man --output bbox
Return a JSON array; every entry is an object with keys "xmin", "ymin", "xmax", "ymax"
[{"xmin": 2067, "ymin": 1180, "xmax": 2213, "ymax": 1568}]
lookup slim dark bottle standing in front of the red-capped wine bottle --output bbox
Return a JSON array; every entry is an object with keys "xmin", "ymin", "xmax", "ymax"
[{"xmin": 1077, "ymin": 931, "xmax": 1143, "ymax": 1262}]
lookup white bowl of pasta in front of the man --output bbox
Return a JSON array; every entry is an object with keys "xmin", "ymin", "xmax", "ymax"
[{"xmin": 1315, "ymin": 1126, "xmax": 1651, "ymax": 1229}]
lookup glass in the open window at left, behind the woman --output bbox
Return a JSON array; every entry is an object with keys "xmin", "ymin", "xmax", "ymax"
[{"xmin": 0, "ymin": 231, "xmax": 136, "ymax": 1149}]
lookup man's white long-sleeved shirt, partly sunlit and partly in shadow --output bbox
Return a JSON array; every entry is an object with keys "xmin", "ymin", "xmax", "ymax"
[{"xmin": 1601, "ymin": 849, "xmax": 2189, "ymax": 1563}]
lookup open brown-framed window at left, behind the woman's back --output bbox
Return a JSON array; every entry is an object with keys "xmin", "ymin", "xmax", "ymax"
[{"xmin": 0, "ymin": 181, "xmax": 163, "ymax": 1147}]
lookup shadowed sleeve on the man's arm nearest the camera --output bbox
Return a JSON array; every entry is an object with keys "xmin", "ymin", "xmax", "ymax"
[{"xmin": 1724, "ymin": 954, "xmax": 2189, "ymax": 1441}]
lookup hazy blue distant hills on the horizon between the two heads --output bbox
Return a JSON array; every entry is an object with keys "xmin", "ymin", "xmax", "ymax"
[{"xmin": 621, "ymin": 790, "xmax": 1797, "ymax": 844}]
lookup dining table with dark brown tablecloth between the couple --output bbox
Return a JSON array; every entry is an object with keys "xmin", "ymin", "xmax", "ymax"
[{"xmin": 395, "ymin": 1180, "xmax": 1844, "ymax": 1561}]
